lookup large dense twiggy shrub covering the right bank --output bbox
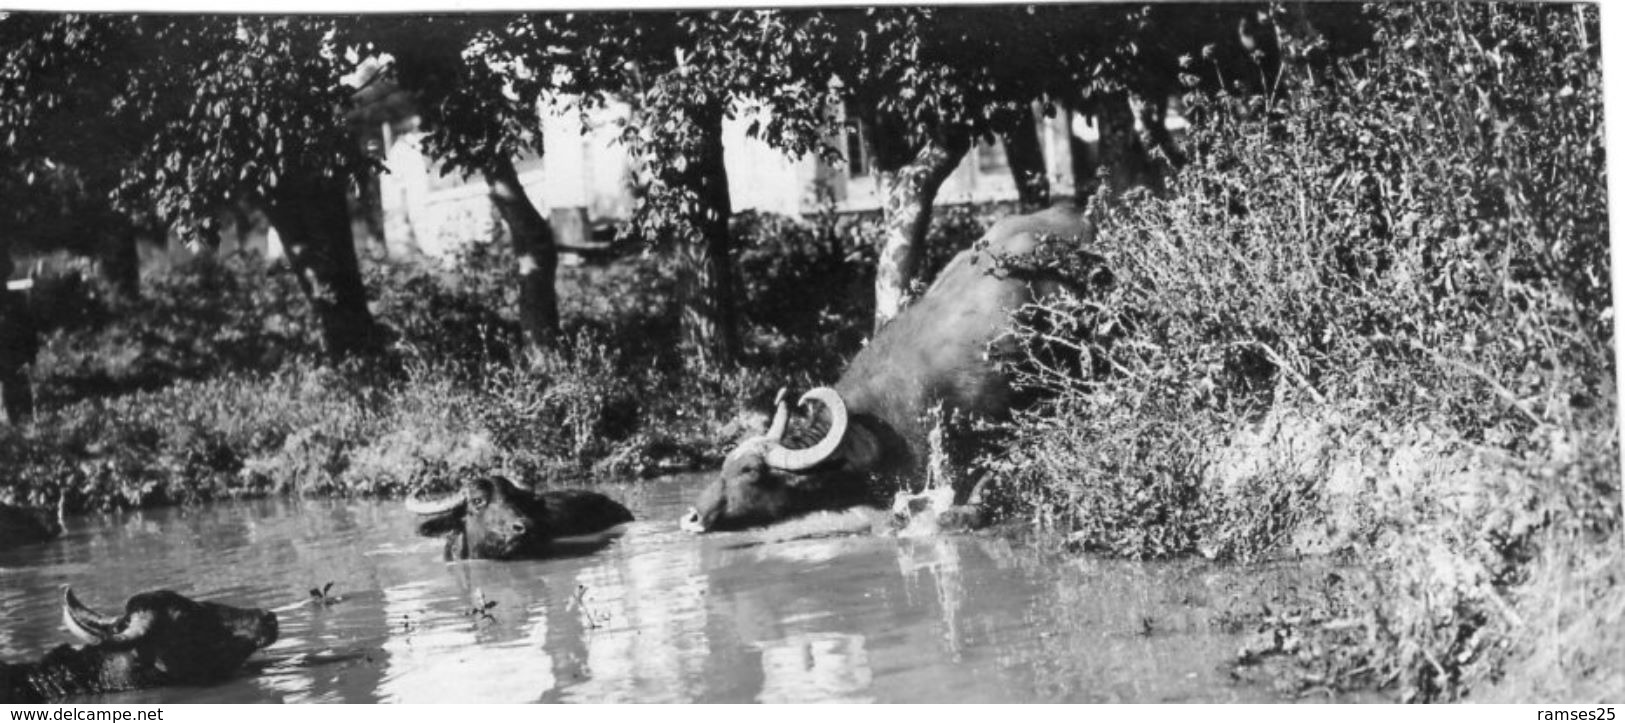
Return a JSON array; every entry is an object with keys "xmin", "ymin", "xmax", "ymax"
[{"xmin": 1001, "ymin": 3, "xmax": 1625, "ymax": 700}]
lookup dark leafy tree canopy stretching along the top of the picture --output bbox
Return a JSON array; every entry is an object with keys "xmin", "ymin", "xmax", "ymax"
[{"xmin": 0, "ymin": 3, "xmax": 1378, "ymax": 352}]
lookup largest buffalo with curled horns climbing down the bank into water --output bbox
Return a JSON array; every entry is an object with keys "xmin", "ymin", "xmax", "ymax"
[{"xmin": 681, "ymin": 205, "xmax": 1094, "ymax": 531}]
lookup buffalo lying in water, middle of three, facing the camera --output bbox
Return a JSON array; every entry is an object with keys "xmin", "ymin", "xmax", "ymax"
[{"xmin": 406, "ymin": 476, "xmax": 632, "ymax": 561}]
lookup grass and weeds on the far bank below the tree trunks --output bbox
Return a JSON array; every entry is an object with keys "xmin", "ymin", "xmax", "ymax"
[{"xmin": 0, "ymin": 191, "xmax": 995, "ymax": 512}]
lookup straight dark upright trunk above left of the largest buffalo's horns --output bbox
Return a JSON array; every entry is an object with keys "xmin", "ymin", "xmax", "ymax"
[{"xmin": 678, "ymin": 104, "xmax": 739, "ymax": 366}]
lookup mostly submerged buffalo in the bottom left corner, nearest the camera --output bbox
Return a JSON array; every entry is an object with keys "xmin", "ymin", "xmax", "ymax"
[{"xmin": 0, "ymin": 588, "xmax": 276, "ymax": 704}]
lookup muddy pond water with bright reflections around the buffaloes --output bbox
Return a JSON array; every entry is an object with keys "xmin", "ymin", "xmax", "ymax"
[{"xmin": 0, "ymin": 478, "xmax": 1319, "ymax": 702}]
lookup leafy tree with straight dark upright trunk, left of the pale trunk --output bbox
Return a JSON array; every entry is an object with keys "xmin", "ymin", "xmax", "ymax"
[{"xmin": 526, "ymin": 10, "xmax": 827, "ymax": 364}]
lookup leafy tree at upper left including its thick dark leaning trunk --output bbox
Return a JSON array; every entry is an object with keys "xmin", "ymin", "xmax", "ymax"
[{"xmin": 5, "ymin": 15, "xmax": 379, "ymax": 356}]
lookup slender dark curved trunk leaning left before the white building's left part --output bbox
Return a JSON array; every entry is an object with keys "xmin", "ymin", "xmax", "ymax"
[{"xmin": 484, "ymin": 158, "xmax": 559, "ymax": 359}]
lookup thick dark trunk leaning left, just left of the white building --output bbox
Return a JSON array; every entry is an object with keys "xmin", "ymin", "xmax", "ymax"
[{"xmin": 267, "ymin": 174, "xmax": 384, "ymax": 359}]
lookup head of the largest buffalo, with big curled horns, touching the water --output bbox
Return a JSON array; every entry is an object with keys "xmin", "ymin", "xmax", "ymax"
[{"xmin": 679, "ymin": 387, "xmax": 878, "ymax": 533}]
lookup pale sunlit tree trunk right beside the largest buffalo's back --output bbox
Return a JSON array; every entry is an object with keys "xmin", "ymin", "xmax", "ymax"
[{"xmin": 874, "ymin": 130, "xmax": 970, "ymax": 331}]
